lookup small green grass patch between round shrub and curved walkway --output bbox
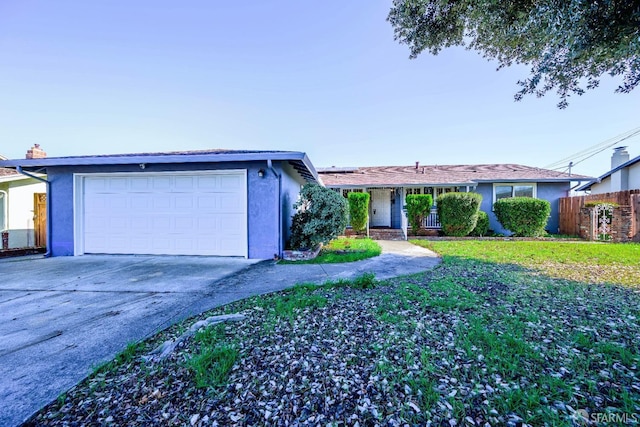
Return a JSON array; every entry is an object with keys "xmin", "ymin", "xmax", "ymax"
[{"xmin": 280, "ymin": 237, "xmax": 382, "ymax": 264}]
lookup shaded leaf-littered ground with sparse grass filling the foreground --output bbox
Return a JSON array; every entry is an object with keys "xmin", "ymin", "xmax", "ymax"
[{"xmin": 28, "ymin": 242, "xmax": 640, "ymax": 426}]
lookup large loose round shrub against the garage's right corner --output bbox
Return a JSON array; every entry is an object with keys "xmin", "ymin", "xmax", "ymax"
[{"xmin": 290, "ymin": 183, "xmax": 348, "ymax": 249}]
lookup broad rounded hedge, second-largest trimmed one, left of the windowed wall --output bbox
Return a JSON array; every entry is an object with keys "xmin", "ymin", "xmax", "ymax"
[{"xmin": 438, "ymin": 193, "xmax": 482, "ymax": 237}]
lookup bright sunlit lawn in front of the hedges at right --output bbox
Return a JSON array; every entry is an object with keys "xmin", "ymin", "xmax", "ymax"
[{"xmin": 411, "ymin": 240, "xmax": 640, "ymax": 289}]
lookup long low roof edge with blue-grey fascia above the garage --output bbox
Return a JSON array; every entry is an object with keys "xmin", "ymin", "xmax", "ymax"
[{"xmin": 0, "ymin": 149, "xmax": 318, "ymax": 181}]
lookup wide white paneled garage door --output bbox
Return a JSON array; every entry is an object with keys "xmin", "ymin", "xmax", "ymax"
[{"xmin": 76, "ymin": 170, "xmax": 247, "ymax": 256}]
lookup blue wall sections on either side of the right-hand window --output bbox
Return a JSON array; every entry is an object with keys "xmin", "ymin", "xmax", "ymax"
[{"xmin": 475, "ymin": 182, "xmax": 570, "ymax": 235}]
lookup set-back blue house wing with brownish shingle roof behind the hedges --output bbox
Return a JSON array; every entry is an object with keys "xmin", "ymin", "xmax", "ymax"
[{"xmin": 318, "ymin": 162, "xmax": 590, "ymax": 237}]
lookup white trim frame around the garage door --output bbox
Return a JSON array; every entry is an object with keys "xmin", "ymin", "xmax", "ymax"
[{"xmin": 73, "ymin": 169, "xmax": 249, "ymax": 258}]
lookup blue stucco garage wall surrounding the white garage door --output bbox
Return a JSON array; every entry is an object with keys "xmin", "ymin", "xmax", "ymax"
[{"xmin": 47, "ymin": 161, "xmax": 299, "ymax": 259}]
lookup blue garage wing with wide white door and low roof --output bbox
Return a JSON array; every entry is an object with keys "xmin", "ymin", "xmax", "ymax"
[{"xmin": 0, "ymin": 150, "xmax": 318, "ymax": 259}]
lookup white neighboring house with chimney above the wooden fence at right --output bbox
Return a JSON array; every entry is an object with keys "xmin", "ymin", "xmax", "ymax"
[{"xmin": 577, "ymin": 147, "xmax": 640, "ymax": 194}]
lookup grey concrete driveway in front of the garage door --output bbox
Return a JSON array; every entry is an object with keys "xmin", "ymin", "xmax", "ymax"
[{"xmin": 0, "ymin": 255, "xmax": 255, "ymax": 426}]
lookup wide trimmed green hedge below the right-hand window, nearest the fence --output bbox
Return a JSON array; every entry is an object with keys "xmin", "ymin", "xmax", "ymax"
[{"xmin": 493, "ymin": 197, "xmax": 551, "ymax": 237}]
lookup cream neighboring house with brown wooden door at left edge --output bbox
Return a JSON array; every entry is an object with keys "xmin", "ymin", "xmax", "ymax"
[{"xmin": 0, "ymin": 145, "xmax": 46, "ymax": 249}]
